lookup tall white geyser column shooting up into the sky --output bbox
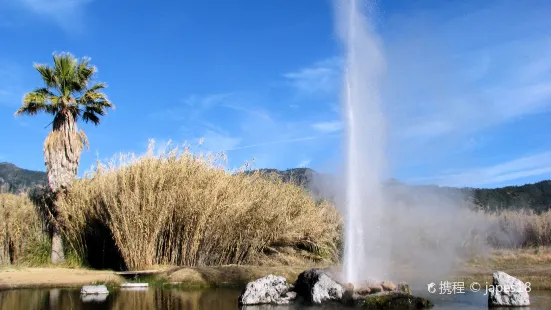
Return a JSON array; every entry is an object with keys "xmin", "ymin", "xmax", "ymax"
[{"xmin": 337, "ymin": 0, "xmax": 390, "ymax": 284}]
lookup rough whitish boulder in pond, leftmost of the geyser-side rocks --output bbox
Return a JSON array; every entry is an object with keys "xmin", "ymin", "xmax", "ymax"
[{"xmin": 239, "ymin": 275, "xmax": 296, "ymax": 305}]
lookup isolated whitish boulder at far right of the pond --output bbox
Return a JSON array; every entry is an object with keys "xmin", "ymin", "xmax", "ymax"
[{"xmin": 488, "ymin": 271, "xmax": 530, "ymax": 307}]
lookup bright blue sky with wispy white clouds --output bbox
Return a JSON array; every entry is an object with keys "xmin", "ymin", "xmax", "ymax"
[{"xmin": 0, "ymin": 0, "xmax": 551, "ymax": 187}]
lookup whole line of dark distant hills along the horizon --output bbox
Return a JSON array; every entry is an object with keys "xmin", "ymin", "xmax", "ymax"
[{"xmin": 0, "ymin": 162, "xmax": 551, "ymax": 212}]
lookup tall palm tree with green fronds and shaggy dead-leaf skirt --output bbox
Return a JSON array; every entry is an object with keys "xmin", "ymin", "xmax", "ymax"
[{"xmin": 15, "ymin": 53, "xmax": 114, "ymax": 264}]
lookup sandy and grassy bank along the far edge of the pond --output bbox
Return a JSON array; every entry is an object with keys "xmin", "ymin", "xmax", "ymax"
[{"xmin": 0, "ymin": 247, "xmax": 551, "ymax": 290}]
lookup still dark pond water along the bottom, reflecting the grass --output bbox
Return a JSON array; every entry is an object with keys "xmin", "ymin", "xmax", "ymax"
[{"xmin": 0, "ymin": 288, "xmax": 551, "ymax": 310}]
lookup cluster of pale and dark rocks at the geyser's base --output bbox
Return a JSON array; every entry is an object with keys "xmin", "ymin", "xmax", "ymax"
[{"xmin": 239, "ymin": 268, "xmax": 432, "ymax": 309}]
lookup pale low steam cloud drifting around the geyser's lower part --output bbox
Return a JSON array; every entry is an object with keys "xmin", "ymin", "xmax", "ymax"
[{"xmin": 311, "ymin": 174, "xmax": 498, "ymax": 287}]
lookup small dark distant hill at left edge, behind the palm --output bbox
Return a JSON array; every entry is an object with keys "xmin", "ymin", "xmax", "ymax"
[{"xmin": 0, "ymin": 162, "xmax": 48, "ymax": 193}]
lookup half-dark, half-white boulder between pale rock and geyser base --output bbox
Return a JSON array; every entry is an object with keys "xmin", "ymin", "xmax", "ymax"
[{"xmin": 295, "ymin": 268, "xmax": 345, "ymax": 304}]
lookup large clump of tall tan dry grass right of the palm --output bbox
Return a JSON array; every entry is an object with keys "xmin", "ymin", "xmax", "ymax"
[{"xmin": 59, "ymin": 140, "xmax": 341, "ymax": 269}]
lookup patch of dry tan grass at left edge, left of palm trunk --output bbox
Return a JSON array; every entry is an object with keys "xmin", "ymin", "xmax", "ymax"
[{"xmin": 0, "ymin": 194, "xmax": 47, "ymax": 265}]
